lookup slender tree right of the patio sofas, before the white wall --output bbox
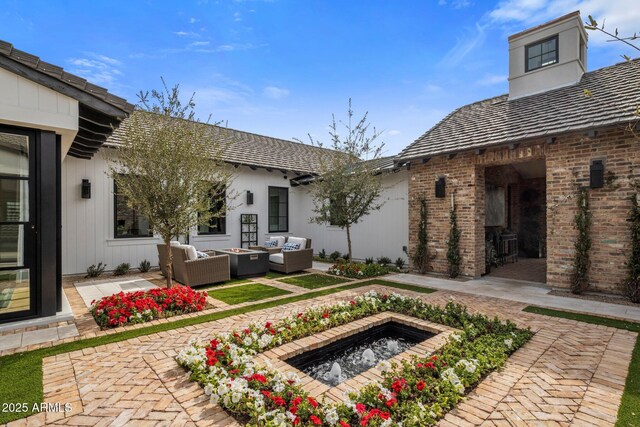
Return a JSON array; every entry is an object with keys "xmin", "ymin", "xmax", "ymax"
[{"xmin": 302, "ymin": 100, "xmax": 384, "ymax": 259}]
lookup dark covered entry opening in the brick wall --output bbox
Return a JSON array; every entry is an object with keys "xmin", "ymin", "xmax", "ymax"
[{"xmin": 484, "ymin": 159, "xmax": 547, "ymax": 283}]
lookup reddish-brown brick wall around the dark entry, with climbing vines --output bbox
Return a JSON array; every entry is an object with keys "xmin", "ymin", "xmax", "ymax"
[{"xmin": 409, "ymin": 126, "xmax": 640, "ymax": 293}]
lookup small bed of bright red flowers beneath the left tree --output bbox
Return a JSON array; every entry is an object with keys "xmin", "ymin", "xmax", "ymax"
[{"xmin": 90, "ymin": 285, "xmax": 207, "ymax": 328}]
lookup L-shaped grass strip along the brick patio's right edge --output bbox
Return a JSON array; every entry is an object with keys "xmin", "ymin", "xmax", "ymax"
[{"xmin": 524, "ymin": 305, "xmax": 640, "ymax": 427}]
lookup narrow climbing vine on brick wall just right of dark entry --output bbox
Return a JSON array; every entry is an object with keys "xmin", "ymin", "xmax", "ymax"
[{"xmin": 571, "ymin": 188, "xmax": 591, "ymax": 294}]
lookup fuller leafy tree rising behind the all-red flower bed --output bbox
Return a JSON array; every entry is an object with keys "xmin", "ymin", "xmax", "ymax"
[{"xmin": 108, "ymin": 80, "xmax": 231, "ymax": 288}]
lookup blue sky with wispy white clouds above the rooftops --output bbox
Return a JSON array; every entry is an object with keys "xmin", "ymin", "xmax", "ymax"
[{"xmin": 0, "ymin": 0, "xmax": 640, "ymax": 155}]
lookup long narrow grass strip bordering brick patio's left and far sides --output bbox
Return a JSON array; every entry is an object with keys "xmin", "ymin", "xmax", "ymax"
[{"xmin": 0, "ymin": 279, "xmax": 435, "ymax": 424}]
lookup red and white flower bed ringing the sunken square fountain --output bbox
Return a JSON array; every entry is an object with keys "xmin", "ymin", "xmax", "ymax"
[{"xmin": 176, "ymin": 291, "xmax": 532, "ymax": 427}]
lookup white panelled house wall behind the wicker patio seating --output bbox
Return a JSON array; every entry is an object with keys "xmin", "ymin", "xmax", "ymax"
[{"xmin": 62, "ymin": 152, "xmax": 408, "ymax": 274}]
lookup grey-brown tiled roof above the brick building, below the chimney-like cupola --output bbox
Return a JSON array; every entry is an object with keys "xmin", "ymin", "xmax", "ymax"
[{"xmin": 397, "ymin": 59, "xmax": 640, "ymax": 161}]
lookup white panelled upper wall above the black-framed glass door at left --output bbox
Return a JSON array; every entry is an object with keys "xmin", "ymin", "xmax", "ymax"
[{"xmin": 0, "ymin": 68, "xmax": 78, "ymax": 153}]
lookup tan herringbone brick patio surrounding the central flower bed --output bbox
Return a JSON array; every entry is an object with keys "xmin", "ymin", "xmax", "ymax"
[{"xmin": 9, "ymin": 286, "xmax": 636, "ymax": 426}]
